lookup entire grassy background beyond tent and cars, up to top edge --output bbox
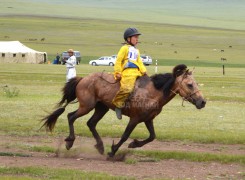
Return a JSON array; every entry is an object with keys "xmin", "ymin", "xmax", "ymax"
[{"xmin": 0, "ymin": 0, "xmax": 245, "ymax": 64}]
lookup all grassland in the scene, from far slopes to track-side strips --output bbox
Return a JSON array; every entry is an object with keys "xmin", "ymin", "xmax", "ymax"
[{"xmin": 0, "ymin": 0, "xmax": 245, "ymax": 179}]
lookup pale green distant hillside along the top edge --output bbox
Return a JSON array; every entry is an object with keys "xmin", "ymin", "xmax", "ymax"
[{"xmin": 0, "ymin": 0, "xmax": 245, "ymax": 30}]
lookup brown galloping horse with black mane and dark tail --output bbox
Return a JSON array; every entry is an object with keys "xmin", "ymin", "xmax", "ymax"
[{"xmin": 41, "ymin": 64, "xmax": 206, "ymax": 157}]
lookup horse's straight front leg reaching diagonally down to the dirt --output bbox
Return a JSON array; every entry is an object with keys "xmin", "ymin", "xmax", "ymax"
[{"xmin": 108, "ymin": 119, "xmax": 138, "ymax": 157}]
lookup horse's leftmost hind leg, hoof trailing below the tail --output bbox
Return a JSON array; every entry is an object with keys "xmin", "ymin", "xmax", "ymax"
[{"xmin": 65, "ymin": 107, "xmax": 91, "ymax": 150}]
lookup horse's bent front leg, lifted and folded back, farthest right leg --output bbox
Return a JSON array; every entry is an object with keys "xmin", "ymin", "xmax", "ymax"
[{"xmin": 128, "ymin": 120, "xmax": 156, "ymax": 148}]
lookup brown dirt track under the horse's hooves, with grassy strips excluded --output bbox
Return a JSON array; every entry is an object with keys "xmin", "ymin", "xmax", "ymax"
[{"xmin": 0, "ymin": 136, "xmax": 245, "ymax": 179}]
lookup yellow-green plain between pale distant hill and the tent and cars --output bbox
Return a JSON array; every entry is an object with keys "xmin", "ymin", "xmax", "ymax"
[{"xmin": 0, "ymin": 16, "xmax": 245, "ymax": 67}]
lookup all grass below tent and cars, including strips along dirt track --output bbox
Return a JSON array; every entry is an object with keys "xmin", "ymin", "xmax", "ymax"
[{"xmin": 0, "ymin": 64, "xmax": 245, "ymax": 179}]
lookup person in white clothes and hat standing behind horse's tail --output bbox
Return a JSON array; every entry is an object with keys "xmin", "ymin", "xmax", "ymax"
[{"xmin": 65, "ymin": 49, "xmax": 77, "ymax": 82}]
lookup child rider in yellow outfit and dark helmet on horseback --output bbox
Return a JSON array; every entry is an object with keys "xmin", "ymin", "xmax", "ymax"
[{"xmin": 112, "ymin": 28, "xmax": 146, "ymax": 119}]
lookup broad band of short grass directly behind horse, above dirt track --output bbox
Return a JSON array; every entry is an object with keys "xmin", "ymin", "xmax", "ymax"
[{"xmin": 0, "ymin": 64, "xmax": 245, "ymax": 144}]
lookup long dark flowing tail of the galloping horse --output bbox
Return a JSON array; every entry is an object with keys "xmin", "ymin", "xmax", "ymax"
[{"xmin": 41, "ymin": 77, "xmax": 82, "ymax": 131}]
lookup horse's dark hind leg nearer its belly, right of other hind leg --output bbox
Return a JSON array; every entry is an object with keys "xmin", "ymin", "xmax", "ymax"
[{"xmin": 87, "ymin": 102, "xmax": 109, "ymax": 154}]
